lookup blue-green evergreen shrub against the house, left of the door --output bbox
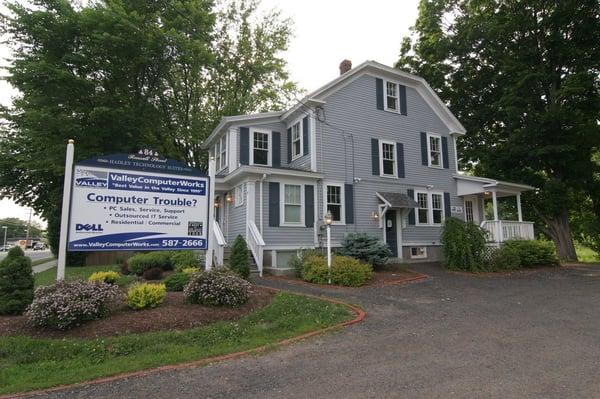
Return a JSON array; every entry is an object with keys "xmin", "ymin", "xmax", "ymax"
[{"xmin": 337, "ymin": 233, "xmax": 392, "ymax": 268}]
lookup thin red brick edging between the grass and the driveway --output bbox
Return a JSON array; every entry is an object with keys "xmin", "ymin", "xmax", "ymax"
[{"xmin": 0, "ymin": 287, "xmax": 367, "ymax": 399}]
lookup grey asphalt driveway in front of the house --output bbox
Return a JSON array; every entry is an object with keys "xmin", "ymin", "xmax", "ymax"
[{"xmin": 29, "ymin": 266, "xmax": 600, "ymax": 399}]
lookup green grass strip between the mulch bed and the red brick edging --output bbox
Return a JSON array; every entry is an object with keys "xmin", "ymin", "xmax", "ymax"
[{"xmin": 0, "ymin": 293, "xmax": 353, "ymax": 394}]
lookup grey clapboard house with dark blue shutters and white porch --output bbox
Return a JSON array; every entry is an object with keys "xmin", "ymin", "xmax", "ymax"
[{"xmin": 204, "ymin": 61, "xmax": 533, "ymax": 273}]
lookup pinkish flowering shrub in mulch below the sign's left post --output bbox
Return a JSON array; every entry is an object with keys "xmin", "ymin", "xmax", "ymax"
[{"xmin": 27, "ymin": 281, "xmax": 121, "ymax": 330}]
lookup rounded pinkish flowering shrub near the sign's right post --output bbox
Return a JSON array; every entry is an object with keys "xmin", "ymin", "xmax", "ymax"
[{"xmin": 183, "ymin": 267, "xmax": 252, "ymax": 306}]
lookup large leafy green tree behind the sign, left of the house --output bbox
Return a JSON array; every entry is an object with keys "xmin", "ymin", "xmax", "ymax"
[{"xmin": 0, "ymin": 0, "xmax": 295, "ymax": 255}]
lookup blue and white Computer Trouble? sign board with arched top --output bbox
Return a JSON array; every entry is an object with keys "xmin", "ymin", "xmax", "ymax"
[{"xmin": 68, "ymin": 150, "xmax": 209, "ymax": 251}]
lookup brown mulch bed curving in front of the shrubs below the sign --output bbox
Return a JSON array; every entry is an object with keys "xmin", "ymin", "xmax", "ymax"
[{"xmin": 0, "ymin": 286, "xmax": 275, "ymax": 338}]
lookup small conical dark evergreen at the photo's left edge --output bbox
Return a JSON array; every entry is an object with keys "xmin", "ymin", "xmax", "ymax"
[{"xmin": 0, "ymin": 247, "xmax": 33, "ymax": 315}]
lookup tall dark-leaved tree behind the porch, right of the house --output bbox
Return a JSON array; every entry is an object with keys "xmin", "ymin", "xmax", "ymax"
[{"xmin": 397, "ymin": 0, "xmax": 600, "ymax": 259}]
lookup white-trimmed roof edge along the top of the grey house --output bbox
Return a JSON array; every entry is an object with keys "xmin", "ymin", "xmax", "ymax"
[{"xmin": 202, "ymin": 61, "xmax": 466, "ymax": 148}]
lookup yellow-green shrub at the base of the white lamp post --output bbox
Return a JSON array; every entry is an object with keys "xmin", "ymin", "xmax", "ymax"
[{"xmin": 302, "ymin": 255, "xmax": 373, "ymax": 287}]
